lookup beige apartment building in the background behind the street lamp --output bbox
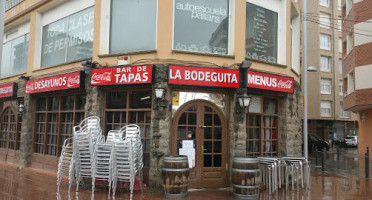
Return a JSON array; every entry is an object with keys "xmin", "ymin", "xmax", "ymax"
[{"xmin": 306, "ymin": 0, "xmax": 357, "ymax": 144}]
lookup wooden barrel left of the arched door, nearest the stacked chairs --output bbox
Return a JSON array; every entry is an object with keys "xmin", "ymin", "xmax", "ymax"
[{"xmin": 161, "ymin": 156, "xmax": 189, "ymax": 198}]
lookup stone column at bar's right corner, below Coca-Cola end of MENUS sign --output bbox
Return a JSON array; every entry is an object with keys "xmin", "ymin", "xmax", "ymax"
[{"xmin": 279, "ymin": 82, "xmax": 303, "ymax": 156}]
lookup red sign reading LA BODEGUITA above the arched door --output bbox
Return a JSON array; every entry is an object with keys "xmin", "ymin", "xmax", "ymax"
[{"xmin": 168, "ymin": 65, "xmax": 239, "ymax": 88}]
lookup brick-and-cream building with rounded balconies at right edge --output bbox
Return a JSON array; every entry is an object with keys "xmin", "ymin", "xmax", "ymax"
[{"xmin": 342, "ymin": 0, "xmax": 372, "ymax": 155}]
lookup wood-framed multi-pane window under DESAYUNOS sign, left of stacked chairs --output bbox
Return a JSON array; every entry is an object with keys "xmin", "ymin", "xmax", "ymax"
[{"xmin": 34, "ymin": 94, "xmax": 85, "ymax": 156}]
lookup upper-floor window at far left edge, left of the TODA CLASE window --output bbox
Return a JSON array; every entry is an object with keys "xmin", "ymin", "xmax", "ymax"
[{"xmin": 0, "ymin": 34, "xmax": 30, "ymax": 78}]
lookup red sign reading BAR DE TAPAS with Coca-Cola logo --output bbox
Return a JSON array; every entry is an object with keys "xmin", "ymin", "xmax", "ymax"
[{"xmin": 91, "ymin": 65, "xmax": 152, "ymax": 85}]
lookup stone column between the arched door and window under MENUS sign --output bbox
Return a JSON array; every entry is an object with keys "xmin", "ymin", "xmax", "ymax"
[{"xmin": 229, "ymin": 88, "xmax": 247, "ymax": 160}]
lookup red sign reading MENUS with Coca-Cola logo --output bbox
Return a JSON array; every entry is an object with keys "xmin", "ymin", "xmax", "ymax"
[{"xmin": 246, "ymin": 71, "xmax": 294, "ymax": 93}]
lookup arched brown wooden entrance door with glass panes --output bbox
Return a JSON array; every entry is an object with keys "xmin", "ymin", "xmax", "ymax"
[{"xmin": 172, "ymin": 100, "xmax": 228, "ymax": 188}]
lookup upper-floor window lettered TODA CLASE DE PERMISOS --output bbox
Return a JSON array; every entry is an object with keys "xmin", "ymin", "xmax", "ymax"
[{"xmin": 41, "ymin": 7, "xmax": 94, "ymax": 67}]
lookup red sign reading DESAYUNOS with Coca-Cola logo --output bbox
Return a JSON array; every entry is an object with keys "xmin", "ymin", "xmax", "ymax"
[{"xmin": 26, "ymin": 71, "xmax": 81, "ymax": 94}]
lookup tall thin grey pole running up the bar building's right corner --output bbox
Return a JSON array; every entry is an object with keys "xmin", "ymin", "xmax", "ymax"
[{"xmin": 302, "ymin": 0, "xmax": 309, "ymax": 160}]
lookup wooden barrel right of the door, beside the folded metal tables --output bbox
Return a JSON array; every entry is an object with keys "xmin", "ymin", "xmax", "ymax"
[{"xmin": 231, "ymin": 157, "xmax": 261, "ymax": 199}]
